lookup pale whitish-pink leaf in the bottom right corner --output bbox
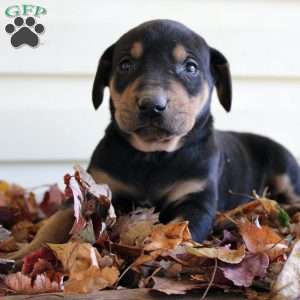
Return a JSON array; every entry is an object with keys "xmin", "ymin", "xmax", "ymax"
[{"xmin": 272, "ymin": 240, "xmax": 300, "ymax": 300}]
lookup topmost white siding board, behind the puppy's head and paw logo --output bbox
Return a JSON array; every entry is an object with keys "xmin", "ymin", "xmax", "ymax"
[{"xmin": 0, "ymin": 0, "xmax": 300, "ymax": 78}]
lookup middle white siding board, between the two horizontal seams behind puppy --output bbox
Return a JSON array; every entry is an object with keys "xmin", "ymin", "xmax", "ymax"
[{"xmin": 0, "ymin": 76, "xmax": 300, "ymax": 161}]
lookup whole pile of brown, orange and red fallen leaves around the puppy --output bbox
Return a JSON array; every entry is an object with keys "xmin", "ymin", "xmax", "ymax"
[{"xmin": 0, "ymin": 167, "xmax": 300, "ymax": 299}]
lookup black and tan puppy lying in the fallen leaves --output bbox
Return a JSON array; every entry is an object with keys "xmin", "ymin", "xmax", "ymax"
[{"xmin": 88, "ymin": 20, "xmax": 300, "ymax": 241}]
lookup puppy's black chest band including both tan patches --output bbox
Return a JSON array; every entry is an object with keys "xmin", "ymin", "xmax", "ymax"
[{"xmin": 91, "ymin": 169, "xmax": 207, "ymax": 207}]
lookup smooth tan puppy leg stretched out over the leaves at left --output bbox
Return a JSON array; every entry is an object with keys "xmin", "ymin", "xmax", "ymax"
[{"xmin": 6, "ymin": 208, "xmax": 74, "ymax": 262}]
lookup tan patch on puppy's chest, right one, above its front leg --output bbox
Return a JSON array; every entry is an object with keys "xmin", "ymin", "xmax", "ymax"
[{"xmin": 162, "ymin": 179, "xmax": 207, "ymax": 205}]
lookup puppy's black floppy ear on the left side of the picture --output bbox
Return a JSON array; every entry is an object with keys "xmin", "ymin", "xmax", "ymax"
[{"xmin": 92, "ymin": 44, "xmax": 115, "ymax": 109}]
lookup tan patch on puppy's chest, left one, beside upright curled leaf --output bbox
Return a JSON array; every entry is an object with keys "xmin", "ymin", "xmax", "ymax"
[{"xmin": 89, "ymin": 168, "xmax": 137, "ymax": 195}]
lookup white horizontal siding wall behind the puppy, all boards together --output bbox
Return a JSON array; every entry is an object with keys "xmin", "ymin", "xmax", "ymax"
[{"xmin": 0, "ymin": 0, "xmax": 300, "ymax": 186}]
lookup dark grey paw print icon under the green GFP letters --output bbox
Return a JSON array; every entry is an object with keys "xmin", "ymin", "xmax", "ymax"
[{"xmin": 5, "ymin": 17, "xmax": 45, "ymax": 48}]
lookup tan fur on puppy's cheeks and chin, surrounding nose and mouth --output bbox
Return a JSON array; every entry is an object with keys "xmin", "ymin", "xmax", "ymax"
[{"xmin": 110, "ymin": 77, "xmax": 209, "ymax": 152}]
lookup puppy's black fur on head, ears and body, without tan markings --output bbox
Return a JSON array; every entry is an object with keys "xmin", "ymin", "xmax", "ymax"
[{"xmin": 88, "ymin": 20, "xmax": 300, "ymax": 241}]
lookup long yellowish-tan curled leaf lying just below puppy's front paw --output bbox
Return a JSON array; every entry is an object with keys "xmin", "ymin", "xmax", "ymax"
[{"xmin": 186, "ymin": 245, "xmax": 246, "ymax": 264}]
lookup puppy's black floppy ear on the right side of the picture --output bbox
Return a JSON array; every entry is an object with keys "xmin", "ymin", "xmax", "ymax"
[{"xmin": 210, "ymin": 48, "xmax": 232, "ymax": 112}]
